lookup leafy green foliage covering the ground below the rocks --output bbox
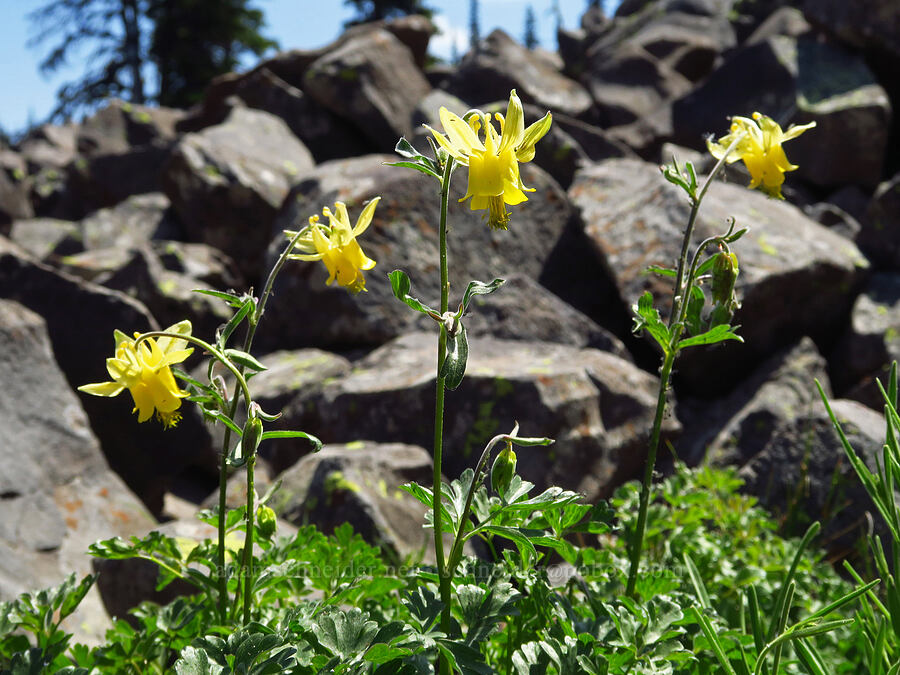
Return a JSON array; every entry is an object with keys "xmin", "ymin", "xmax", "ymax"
[{"xmin": 0, "ymin": 464, "xmax": 880, "ymax": 675}]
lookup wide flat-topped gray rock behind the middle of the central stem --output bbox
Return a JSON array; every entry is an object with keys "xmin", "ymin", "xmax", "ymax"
[{"xmin": 284, "ymin": 333, "xmax": 679, "ymax": 499}]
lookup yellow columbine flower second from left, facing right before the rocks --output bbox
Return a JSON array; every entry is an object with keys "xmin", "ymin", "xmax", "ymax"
[{"xmin": 284, "ymin": 197, "xmax": 381, "ymax": 293}]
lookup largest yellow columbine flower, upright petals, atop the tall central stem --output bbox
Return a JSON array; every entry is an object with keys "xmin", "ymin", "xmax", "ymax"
[{"xmin": 425, "ymin": 89, "xmax": 553, "ymax": 230}]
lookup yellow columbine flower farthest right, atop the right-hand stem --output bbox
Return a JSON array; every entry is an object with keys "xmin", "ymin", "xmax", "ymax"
[{"xmin": 706, "ymin": 113, "xmax": 816, "ymax": 199}]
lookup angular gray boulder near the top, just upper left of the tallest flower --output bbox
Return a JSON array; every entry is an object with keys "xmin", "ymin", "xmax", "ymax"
[{"xmin": 303, "ymin": 30, "xmax": 431, "ymax": 152}]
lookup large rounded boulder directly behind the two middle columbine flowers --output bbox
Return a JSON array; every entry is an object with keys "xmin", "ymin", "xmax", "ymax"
[{"xmin": 258, "ymin": 155, "xmax": 570, "ymax": 349}]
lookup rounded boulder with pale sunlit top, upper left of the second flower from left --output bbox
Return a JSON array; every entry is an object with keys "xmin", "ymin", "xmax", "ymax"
[{"xmin": 163, "ymin": 108, "xmax": 313, "ymax": 281}]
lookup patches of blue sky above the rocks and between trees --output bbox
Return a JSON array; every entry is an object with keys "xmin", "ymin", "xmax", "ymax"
[{"xmin": 0, "ymin": 0, "xmax": 617, "ymax": 133}]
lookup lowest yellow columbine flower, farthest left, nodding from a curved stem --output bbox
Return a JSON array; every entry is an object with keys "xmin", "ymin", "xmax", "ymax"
[{"xmin": 78, "ymin": 321, "xmax": 194, "ymax": 429}]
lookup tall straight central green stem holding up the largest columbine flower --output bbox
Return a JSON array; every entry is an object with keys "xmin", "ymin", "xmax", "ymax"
[{"xmin": 432, "ymin": 157, "xmax": 453, "ymax": 675}]
